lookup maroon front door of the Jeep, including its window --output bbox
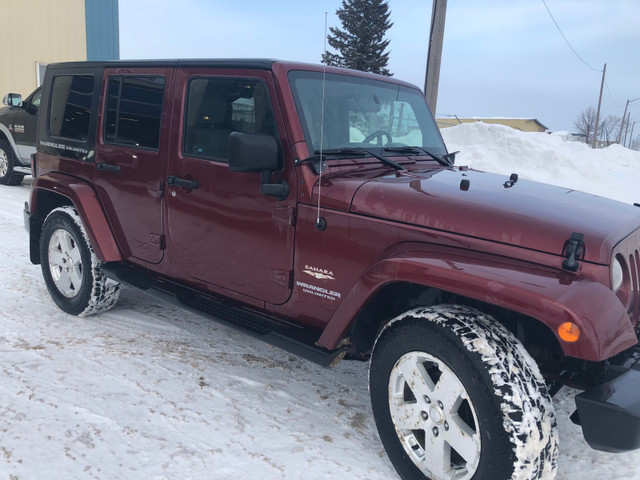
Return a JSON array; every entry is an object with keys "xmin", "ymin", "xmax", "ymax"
[{"xmin": 166, "ymin": 69, "xmax": 295, "ymax": 304}]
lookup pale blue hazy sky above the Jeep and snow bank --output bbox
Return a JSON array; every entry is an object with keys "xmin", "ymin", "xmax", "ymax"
[{"xmin": 120, "ymin": 0, "xmax": 640, "ymax": 131}]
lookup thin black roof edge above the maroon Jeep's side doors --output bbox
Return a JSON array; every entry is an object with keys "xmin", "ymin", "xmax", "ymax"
[{"xmin": 47, "ymin": 58, "xmax": 276, "ymax": 70}]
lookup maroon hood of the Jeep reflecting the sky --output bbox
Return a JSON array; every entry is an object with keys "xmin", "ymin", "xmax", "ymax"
[{"xmin": 344, "ymin": 165, "xmax": 640, "ymax": 264}]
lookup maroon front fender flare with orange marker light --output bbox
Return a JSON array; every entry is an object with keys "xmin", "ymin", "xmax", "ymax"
[{"xmin": 318, "ymin": 246, "xmax": 637, "ymax": 361}]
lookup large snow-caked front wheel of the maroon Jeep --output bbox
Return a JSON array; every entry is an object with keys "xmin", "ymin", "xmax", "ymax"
[{"xmin": 369, "ymin": 305, "xmax": 558, "ymax": 480}]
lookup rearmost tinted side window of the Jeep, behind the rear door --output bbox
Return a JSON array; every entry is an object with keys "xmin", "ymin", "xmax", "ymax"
[{"xmin": 49, "ymin": 75, "xmax": 94, "ymax": 141}]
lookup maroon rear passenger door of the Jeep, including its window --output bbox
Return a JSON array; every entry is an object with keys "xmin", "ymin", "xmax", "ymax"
[{"xmin": 95, "ymin": 68, "xmax": 173, "ymax": 264}]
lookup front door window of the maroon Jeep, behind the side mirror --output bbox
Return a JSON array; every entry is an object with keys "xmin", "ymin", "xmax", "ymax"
[{"xmin": 182, "ymin": 78, "xmax": 277, "ymax": 162}]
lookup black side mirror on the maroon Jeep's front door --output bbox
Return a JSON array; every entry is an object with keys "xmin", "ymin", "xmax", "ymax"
[{"xmin": 229, "ymin": 132, "xmax": 289, "ymax": 200}]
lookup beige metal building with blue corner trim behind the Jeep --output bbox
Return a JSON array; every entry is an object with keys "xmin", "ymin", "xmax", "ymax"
[{"xmin": 0, "ymin": 0, "xmax": 119, "ymax": 98}]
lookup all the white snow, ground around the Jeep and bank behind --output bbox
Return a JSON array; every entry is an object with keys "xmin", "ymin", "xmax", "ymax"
[{"xmin": 0, "ymin": 124, "xmax": 640, "ymax": 480}]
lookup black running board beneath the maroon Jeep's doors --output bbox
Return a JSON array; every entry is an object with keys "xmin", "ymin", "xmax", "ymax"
[{"xmin": 101, "ymin": 262, "xmax": 346, "ymax": 367}]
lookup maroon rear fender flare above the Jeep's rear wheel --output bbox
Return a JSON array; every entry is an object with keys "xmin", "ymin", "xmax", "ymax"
[{"xmin": 30, "ymin": 172, "xmax": 122, "ymax": 262}]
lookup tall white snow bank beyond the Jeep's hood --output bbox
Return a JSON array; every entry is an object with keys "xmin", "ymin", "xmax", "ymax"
[{"xmin": 442, "ymin": 122, "xmax": 640, "ymax": 203}]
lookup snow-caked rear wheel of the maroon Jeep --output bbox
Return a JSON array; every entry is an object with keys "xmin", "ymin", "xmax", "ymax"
[{"xmin": 40, "ymin": 207, "xmax": 120, "ymax": 317}]
